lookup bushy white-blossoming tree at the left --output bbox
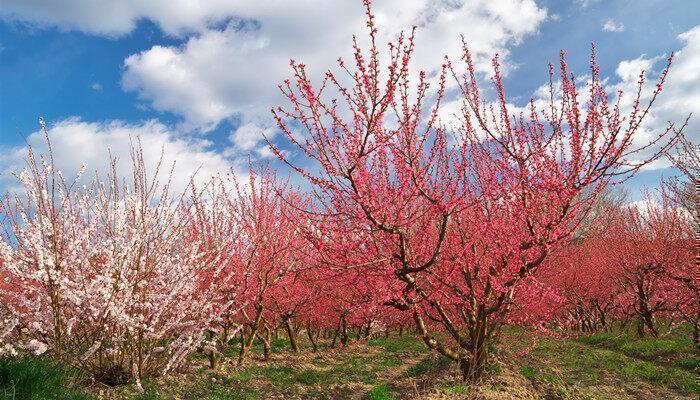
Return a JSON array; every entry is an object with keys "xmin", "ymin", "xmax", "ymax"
[{"xmin": 0, "ymin": 123, "xmax": 241, "ymax": 387}]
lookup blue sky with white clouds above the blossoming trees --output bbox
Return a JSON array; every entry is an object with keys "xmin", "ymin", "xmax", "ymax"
[{"xmin": 0, "ymin": 0, "xmax": 700, "ymax": 201}]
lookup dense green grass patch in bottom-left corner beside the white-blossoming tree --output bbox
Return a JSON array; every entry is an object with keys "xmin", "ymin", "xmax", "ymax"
[{"xmin": 0, "ymin": 357, "xmax": 91, "ymax": 400}]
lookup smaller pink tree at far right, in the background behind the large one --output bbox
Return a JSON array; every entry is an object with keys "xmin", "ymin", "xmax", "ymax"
[{"xmin": 608, "ymin": 199, "xmax": 698, "ymax": 337}]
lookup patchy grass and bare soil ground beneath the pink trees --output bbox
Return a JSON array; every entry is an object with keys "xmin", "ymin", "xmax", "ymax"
[{"xmin": 0, "ymin": 329, "xmax": 700, "ymax": 400}]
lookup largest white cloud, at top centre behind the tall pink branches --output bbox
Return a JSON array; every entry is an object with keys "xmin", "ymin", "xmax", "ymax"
[{"xmin": 122, "ymin": 0, "xmax": 547, "ymax": 132}]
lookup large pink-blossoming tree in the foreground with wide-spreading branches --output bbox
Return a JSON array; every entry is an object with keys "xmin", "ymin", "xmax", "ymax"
[{"xmin": 272, "ymin": 1, "xmax": 688, "ymax": 382}]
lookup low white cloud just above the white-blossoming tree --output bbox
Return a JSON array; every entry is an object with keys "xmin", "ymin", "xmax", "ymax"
[{"xmin": 0, "ymin": 118, "xmax": 238, "ymax": 192}]
